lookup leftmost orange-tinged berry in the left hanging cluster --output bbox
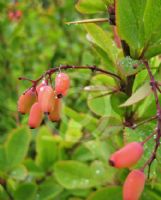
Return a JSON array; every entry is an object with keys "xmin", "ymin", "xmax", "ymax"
[{"xmin": 18, "ymin": 88, "xmax": 37, "ymax": 114}]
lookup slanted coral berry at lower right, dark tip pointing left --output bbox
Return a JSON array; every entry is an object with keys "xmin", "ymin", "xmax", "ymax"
[{"xmin": 109, "ymin": 142, "xmax": 144, "ymax": 168}]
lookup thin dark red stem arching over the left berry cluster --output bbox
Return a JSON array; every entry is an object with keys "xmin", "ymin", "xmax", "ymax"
[{"xmin": 19, "ymin": 65, "xmax": 121, "ymax": 86}]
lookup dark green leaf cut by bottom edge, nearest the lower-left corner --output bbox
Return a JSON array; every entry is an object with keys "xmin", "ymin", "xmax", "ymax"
[{"xmin": 14, "ymin": 183, "xmax": 36, "ymax": 200}]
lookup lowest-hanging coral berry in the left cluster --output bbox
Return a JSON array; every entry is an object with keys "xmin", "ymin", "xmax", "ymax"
[{"xmin": 28, "ymin": 102, "xmax": 43, "ymax": 129}]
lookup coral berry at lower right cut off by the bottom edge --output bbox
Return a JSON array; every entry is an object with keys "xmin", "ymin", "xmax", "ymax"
[{"xmin": 123, "ymin": 170, "xmax": 146, "ymax": 200}]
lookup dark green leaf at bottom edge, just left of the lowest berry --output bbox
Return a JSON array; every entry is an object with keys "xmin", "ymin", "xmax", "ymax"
[{"xmin": 87, "ymin": 186, "xmax": 122, "ymax": 200}]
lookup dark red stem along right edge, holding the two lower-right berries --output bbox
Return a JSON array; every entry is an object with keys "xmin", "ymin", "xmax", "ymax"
[{"xmin": 142, "ymin": 60, "xmax": 161, "ymax": 177}]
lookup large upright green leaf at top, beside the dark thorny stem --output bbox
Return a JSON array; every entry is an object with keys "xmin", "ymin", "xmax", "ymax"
[{"xmin": 116, "ymin": 0, "xmax": 147, "ymax": 58}]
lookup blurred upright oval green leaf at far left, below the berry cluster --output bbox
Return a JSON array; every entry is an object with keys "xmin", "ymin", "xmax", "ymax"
[{"xmin": 5, "ymin": 127, "xmax": 30, "ymax": 169}]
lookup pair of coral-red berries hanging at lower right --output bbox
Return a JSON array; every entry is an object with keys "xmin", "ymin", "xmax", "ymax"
[{"xmin": 109, "ymin": 142, "xmax": 146, "ymax": 200}]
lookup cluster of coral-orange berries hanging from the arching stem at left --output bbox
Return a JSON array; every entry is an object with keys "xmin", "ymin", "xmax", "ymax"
[{"xmin": 18, "ymin": 73, "xmax": 70, "ymax": 129}]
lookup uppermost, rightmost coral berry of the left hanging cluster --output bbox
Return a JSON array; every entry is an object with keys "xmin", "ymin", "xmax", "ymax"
[{"xmin": 55, "ymin": 73, "xmax": 70, "ymax": 96}]
